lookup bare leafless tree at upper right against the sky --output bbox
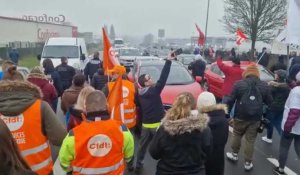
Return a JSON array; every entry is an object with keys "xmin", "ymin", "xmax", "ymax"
[{"xmin": 223, "ymin": 0, "xmax": 287, "ymax": 58}]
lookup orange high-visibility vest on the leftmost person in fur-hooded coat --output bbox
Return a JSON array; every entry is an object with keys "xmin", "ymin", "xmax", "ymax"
[{"xmin": 0, "ymin": 100, "xmax": 53, "ymax": 175}]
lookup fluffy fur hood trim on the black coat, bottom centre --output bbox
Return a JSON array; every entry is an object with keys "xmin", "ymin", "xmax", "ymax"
[{"xmin": 162, "ymin": 113, "xmax": 209, "ymax": 136}]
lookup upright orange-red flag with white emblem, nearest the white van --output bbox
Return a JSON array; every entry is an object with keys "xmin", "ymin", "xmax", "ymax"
[{"xmin": 102, "ymin": 28, "xmax": 120, "ymax": 74}]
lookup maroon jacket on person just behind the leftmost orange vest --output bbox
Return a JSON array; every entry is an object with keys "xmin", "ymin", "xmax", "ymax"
[{"xmin": 27, "ymin": 73, "xmax": 57, "ymax": 108}]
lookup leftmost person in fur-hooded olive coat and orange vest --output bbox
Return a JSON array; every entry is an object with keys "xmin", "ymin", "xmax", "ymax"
[{"xmin": 0, "ymin": 81, "xmax": 67, "ymax": 175}]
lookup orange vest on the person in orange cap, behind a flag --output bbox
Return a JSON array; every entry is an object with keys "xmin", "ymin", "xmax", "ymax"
[{"xmin": 108, "ymin": 80, "xmax": 136, "ymax": 128}]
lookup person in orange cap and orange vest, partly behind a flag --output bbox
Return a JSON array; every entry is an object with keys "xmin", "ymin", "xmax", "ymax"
[{"xmin": 102, "ymin": 65, "xmax": 136, "ymax": 129}]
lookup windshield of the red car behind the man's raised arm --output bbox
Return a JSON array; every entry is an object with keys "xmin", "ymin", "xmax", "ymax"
[{"xmin": 139, "ymin": 65, "xmax": 194, "ymax": 85}]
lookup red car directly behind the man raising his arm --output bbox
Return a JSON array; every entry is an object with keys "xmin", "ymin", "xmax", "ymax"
[{"xmin": 128, "ymin": 60, "xmax": 203, "ymax": 109}]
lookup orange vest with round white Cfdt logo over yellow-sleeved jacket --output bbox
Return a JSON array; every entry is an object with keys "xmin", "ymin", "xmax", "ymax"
[{"xmin": 72, "ymin": 120, "xmax": 125, "ymax": 175}]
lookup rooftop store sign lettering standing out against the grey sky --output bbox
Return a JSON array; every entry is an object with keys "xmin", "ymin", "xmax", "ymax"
[{"xmin": 22, "ymin": 14, "xmax": 66, "ymax": 24}]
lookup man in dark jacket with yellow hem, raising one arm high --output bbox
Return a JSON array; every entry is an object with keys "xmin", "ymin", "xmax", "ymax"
[{"xmin": 135, "ymin": 51, "xmax": 176, "ymax": 173}]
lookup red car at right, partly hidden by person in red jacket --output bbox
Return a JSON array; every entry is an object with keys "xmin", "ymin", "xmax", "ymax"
[{"xmin": 204, "ymin": 61, "xmax": 274, "ymax": 98}]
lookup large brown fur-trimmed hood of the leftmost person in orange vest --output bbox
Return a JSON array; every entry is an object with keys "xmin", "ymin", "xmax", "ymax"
[{"xmin": 0, "ymin": 81, "xmax": 43, "ymax": 116}]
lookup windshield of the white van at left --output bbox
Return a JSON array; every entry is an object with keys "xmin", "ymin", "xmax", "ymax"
[{"xmin": 42, "ymin": 46, "xmax": 79, "ymax": 58}]
